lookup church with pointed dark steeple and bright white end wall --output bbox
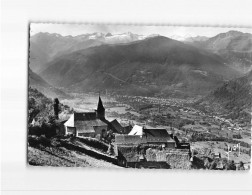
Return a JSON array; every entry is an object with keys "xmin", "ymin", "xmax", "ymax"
[{"xmin": 64, "ymin": 96, "xmax": 108, "ymax": 137}]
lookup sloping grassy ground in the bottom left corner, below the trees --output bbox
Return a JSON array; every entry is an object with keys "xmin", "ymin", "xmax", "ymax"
[{"xmin": 27, "ymin": 136, "xmax": 120, "ymax": 168}]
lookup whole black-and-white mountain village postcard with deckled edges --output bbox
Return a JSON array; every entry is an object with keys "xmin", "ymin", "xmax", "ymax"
[{"xmin": 27, "ymin": 22, "xmax": 252, "ymax": 171}]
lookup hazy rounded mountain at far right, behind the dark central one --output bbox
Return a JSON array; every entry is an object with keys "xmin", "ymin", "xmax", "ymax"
[{"xmin": 192, "ymin": 31, "xmax": 252, "ymax": 73}]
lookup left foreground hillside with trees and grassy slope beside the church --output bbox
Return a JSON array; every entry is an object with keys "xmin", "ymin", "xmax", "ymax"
[{"xmin": 27, "ymin": 88, "xmax": 118, "ymax": 168}]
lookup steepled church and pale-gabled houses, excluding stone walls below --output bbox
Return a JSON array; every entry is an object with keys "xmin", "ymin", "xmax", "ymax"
[{"xmin": 63, "ymin": 96, "xmax": 175, "ymax": 148}]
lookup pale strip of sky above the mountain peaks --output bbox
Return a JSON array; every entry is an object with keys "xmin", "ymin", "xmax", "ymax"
[{"xmin": 30, "ymin": 23, "xmax": 252, "ymax": 37}]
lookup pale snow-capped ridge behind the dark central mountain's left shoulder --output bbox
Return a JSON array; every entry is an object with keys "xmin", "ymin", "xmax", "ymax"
[{"xmin": 30, "ymin": 32, "xmax": 157, "ymax": 73}]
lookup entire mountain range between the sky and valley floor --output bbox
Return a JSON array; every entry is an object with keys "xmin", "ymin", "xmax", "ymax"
[{"xmin": 29, "ymin": 31, "xmax": 252, "ymax": 97}]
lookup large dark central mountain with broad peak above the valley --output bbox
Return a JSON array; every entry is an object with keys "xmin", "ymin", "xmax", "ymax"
[{"xmin": 40, "ymin": 36, "xmax": 237, "ymax": 96}]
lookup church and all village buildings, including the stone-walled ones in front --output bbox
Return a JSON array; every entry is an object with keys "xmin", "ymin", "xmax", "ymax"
[{"xmin": 60, "ymin": 97, "xmax": 191, "ymax": 169}]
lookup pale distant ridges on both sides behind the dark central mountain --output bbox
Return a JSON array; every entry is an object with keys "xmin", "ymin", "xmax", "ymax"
[{"xmin": 29, "ymin": 31, "xmax": 252, "ymax": 74}]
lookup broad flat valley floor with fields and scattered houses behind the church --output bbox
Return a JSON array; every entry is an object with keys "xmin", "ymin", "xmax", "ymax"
[{"xmin": 58, "ymin": 93, "xmax": 251, "ymax": 166}]
